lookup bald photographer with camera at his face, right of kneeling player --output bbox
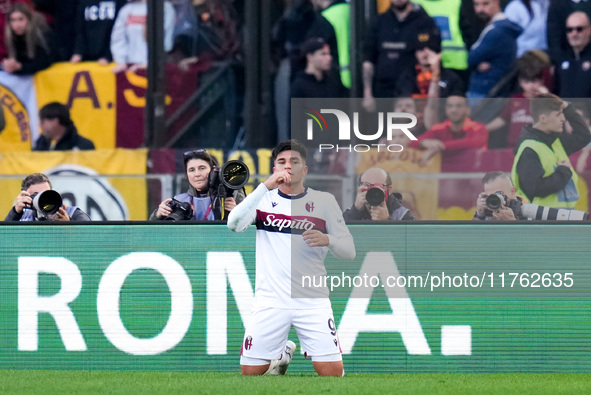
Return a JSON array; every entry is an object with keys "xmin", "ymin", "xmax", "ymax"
[{"xmin": 343, "ymin": 167, "xmax": 415, "ymax": 222}]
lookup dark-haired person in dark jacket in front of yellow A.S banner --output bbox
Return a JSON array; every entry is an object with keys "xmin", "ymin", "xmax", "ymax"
[{"xmin": 34, "ymin": 102, "xmax": 94, "ymax": 151}]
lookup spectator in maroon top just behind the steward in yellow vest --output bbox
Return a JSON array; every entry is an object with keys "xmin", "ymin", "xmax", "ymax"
[{"xmin": 486, "ymin": 51, "xmax": 550, "ymax": 149}]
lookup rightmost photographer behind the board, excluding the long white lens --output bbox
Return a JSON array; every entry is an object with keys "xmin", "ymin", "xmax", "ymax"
[{"xmin": 473, "ymin": 171, "xmax": 526, "ymax": 221}]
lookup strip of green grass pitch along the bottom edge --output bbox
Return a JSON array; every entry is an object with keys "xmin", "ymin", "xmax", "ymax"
[{"xmin": 0, "ymin": 370, "xmax": 591, "ymax": 395}]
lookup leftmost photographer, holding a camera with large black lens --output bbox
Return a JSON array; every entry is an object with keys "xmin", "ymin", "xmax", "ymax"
[{"xmin": 4, "ymin": 173, "xmax": 91, "ymax": 221}]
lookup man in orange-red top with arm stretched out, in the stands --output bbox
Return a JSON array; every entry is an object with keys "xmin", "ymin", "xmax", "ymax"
[{"xmin": 410, "ymin": 96, "xmax": 488, "ymax": 165}]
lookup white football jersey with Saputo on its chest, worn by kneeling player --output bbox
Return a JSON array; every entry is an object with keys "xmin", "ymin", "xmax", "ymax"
[{"xmin": 228, "ymin": 185, "xmax": 355, "ymax": 309}]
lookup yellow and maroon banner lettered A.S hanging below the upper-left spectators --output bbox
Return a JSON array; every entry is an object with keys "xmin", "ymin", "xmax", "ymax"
[{"xmin": 0, "ymin": 62, "xmax": 204, "ymax": 152}]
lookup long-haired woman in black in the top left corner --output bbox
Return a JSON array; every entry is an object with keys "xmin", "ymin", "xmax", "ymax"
[{"xmin": 0, "ymin": 3, "xmax": 54, "ymax": 74}]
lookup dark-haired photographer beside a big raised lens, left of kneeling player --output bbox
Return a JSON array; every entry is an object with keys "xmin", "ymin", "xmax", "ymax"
[{"xmin": 150, "ymin": 149, "xmax": 248, "ymax": 221}]
